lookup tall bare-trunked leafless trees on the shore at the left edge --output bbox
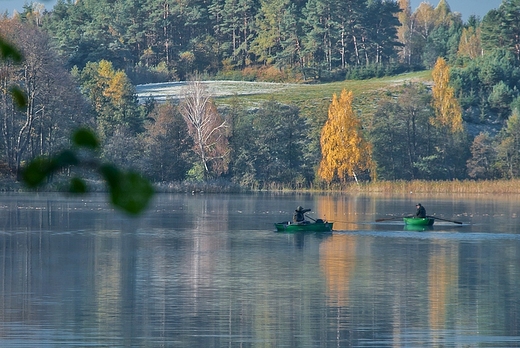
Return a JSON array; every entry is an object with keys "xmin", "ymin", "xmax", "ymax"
[{"xmin": 0, "ymin": 19, "xmax": 90, "ymax": 178}]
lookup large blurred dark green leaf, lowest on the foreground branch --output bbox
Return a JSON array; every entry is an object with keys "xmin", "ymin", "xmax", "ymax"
[{"xmin": 102, "ymin": 171, "xmax": 154, "ymax": 215}]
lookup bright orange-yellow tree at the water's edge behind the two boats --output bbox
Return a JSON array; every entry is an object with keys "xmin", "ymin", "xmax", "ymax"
[{"xmin": 318, "ymin": 89, "xmax": 373, "ymax": 183}]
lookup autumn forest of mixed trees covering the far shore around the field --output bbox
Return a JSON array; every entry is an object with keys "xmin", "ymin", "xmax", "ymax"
[{"xmin": 0, "ymin": 0, "xmax": 520, "ymax": 189}]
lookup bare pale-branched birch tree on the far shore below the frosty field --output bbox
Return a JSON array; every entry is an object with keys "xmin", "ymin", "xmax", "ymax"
[{"xmin": 179, "ymin": 81, "xmax": 229, "ymax": 178}]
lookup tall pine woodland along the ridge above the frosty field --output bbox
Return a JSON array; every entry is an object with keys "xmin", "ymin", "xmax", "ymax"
[{"xmin": 22, "ymin": 0, "xmax": 474, "ymax": 83}]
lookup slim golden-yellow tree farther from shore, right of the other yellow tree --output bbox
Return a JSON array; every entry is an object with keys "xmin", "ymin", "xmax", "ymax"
[{"xmin": 431, "ymin": 58, "xmax": 462, "ymax": 133}]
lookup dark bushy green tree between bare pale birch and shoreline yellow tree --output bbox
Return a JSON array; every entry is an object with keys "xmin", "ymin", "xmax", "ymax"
[{"xmin": 232, "ymin": 99, "xmax": 312, "ymax": 188}]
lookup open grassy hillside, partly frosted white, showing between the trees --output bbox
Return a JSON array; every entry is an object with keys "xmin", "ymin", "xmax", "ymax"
[{"xmin": 136, "ymin": 70, "xmax": 502, "ymax": 137}]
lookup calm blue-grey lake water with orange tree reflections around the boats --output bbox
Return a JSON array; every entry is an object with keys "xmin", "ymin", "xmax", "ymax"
[{"xmin": 0, "ymin": 193, "xmax": 520, "ymax": 347}]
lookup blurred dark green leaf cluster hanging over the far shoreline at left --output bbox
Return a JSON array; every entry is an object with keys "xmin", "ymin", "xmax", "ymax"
[{"xmin": 22, "ymin": 128, "xmax": 154, "ymax": 215}]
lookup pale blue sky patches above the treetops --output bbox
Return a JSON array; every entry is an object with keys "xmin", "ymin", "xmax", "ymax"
[{"xmin": 0, "ymin": 0, "xmax": 502, "ymax": 20}]
